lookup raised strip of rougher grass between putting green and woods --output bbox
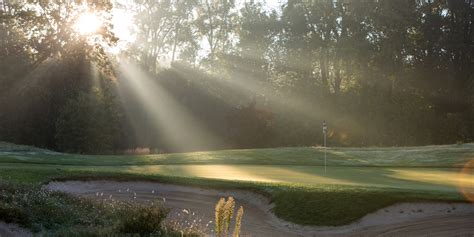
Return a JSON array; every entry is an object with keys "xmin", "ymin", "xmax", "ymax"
[{"xmin": 0, "ymin": 142, "xmax": 474, "ymax": 168}]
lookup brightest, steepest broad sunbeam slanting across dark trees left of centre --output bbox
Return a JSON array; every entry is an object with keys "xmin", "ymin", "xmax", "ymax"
[{"xmin": 115, "ymin": 60, "xmax": 223, "ymax": 150}]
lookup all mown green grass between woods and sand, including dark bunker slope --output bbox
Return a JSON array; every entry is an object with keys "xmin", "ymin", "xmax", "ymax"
[{"xmin": 0, "ymin": 144, "xmax": 474, "ymax": 225}]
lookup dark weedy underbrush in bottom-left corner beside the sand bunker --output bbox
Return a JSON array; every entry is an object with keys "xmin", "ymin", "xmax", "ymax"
[{"xmin": 0, "ymin": 183, "xmax": 200, "ymax": 236}]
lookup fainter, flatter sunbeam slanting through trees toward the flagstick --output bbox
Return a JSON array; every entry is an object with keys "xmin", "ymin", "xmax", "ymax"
[{"xmin": 173, "ymin": 60, "xmax": 362, "ymax": 143}]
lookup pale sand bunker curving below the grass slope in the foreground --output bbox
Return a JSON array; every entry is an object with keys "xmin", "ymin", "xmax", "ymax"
[{"xmin": 47, "ymin": 181, "xmax": 474, "ymax": 236}]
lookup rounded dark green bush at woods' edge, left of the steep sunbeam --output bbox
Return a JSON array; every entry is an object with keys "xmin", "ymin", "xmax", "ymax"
[{"xmin": 56, "ymin": 90, "xmax": 118, "ymax": 153}]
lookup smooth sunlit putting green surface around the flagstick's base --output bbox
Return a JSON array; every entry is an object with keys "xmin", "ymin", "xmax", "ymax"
[{"xmin": 90, "ymin": 165, "xmax": 474, "ymax": 191}]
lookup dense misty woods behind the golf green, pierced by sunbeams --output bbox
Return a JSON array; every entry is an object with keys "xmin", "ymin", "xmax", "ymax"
[{"xmin": 0, "ymin": 0, "xmax": 474, "ymax": 153}]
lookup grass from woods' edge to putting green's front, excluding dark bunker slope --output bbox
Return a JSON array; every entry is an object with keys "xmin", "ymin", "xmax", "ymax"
[{"xmin": 0, "ymin": 143, "xmax": 474, "ymax": 192}]
